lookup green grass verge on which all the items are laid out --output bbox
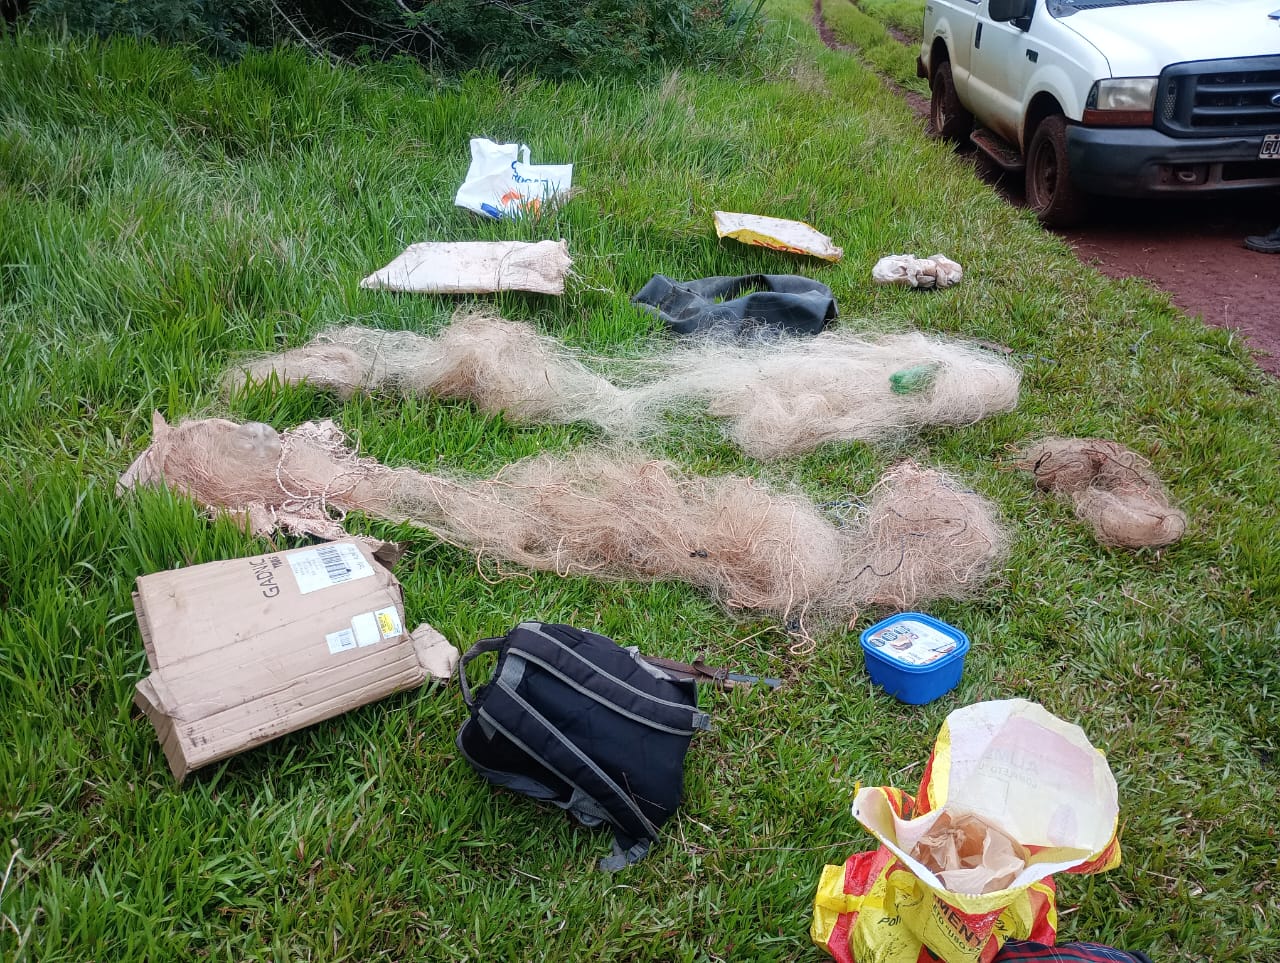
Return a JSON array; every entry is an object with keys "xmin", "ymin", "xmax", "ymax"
[{"xmin": 0, "ymin": 0, "xmax": 1280, "ymax": 963}]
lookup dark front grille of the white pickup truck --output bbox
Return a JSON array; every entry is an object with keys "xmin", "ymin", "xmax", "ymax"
[{"xmin": 1156, "ymin": 56, "xmax": 1280, "ymax": 137}]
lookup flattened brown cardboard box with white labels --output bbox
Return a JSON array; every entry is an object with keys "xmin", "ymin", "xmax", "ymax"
[{"xmin": 133, "ymin": 540, "xmax": 457, "ymax": 781}]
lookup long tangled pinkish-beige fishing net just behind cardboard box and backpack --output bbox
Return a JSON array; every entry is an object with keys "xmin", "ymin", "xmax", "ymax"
[{"xmin": 120, "ymin": 415, "xmax": 1006, "ymax": 630}]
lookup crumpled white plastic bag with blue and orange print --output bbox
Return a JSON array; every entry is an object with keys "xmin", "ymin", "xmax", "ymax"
[{"xmin": 453, "ymin": 137, "xmax": 573, "ymax": 220}]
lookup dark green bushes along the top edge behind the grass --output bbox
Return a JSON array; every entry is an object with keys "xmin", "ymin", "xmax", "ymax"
[{"xmin": 20, "ymin": 0, "xmax": 762, "ymax": 76}]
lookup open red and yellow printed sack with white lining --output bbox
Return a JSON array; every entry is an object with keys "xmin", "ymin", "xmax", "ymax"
[{"xmin": 810, "ymin": 699, "xmax": 1120, "ymax": 963}]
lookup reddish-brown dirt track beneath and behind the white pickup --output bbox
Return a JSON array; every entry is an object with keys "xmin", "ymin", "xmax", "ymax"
[{"xmin": 813, "ymin": 0, "xmax": 1280, "ymax": 375}]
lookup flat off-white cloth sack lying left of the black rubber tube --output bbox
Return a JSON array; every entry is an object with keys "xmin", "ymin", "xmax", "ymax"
[{"xmin": 360, "ymin": 241, "xmax": 572, "ymax": 295}]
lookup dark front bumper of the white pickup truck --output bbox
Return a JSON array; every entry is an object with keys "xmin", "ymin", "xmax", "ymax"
[{"xmin": 1066, "ymin": 124, "xmax": 1280, "ymax": 197}]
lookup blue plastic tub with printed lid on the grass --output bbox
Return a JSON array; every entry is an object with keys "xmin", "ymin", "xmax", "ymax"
[{"xmin": 861, "ymin": 612, "xmax": 969, "ymax": 706}]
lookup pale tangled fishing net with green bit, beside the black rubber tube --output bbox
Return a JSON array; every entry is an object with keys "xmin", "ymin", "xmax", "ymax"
[{"xmin": 228, "ymin": 309, "xmax": 1020, "ymax": 458}]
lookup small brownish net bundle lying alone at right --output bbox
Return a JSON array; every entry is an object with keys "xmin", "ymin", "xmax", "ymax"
[{"xmin": 1018, "ymin": 438, "xmax": 1187, "ymax": 548}]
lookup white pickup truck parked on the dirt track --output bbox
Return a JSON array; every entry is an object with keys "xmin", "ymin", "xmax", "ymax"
[{"xmin": 916, "ymin": 0, "xmax": 1280, "ymax": 227}]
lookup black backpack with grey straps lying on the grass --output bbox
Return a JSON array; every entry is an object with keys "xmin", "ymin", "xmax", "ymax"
[{"xmin": 457, "ymin": 622, "xmax": 710, "ymax": 871}]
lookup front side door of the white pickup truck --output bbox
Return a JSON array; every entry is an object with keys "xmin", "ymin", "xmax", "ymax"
[{"xmin": 961, "ymin": 0, "xmax": 1044, "ymax": 145}]
